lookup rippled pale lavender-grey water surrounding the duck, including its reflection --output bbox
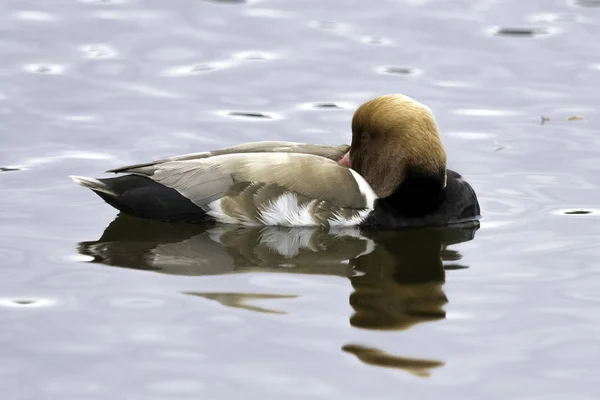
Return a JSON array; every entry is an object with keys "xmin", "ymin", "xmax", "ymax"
[{"xmin": 0, "ymin": 0, "xmax": 600, "ymax": 400}]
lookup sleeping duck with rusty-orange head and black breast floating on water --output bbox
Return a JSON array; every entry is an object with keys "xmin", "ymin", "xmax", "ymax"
[{"xmin": 71, "ymin": 94, "xmax": 481, "ymax": 229}]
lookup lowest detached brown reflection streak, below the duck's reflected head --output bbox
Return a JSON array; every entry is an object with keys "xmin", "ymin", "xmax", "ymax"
[{"xmin": 342, "ymin": 344, "xmax": 444, "ymax": 378}]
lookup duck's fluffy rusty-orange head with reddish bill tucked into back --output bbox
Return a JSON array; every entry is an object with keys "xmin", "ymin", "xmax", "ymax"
[{"xmin": 342, "ymin": 94, "xmax": 446, "ymax": 206}]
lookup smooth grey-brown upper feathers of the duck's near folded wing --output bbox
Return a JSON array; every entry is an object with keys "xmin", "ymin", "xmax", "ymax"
[{"xmin": 123, "ymin": 153, "xmax": 366, "ymax": 209}]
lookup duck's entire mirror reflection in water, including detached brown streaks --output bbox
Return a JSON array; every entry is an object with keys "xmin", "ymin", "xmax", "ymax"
[{"xmin": 79, "ymin": 216, "xmax": 479, "ymax": 375}]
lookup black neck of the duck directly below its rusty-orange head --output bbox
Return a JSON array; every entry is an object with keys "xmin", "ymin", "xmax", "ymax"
[{"xmin": 381, "ymin": 168, "xmax": 446, "ymax": 217}]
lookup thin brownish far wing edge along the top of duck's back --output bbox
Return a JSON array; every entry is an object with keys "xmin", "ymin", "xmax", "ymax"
[{"xmin": 106, "ymin": 141, "xmax": 350, "ymax": 173}]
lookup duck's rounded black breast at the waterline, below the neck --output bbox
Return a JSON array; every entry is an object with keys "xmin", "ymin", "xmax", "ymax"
[{"xmin": 363, "ymin": 170, "xmax": 481, "ymax": 228}]
